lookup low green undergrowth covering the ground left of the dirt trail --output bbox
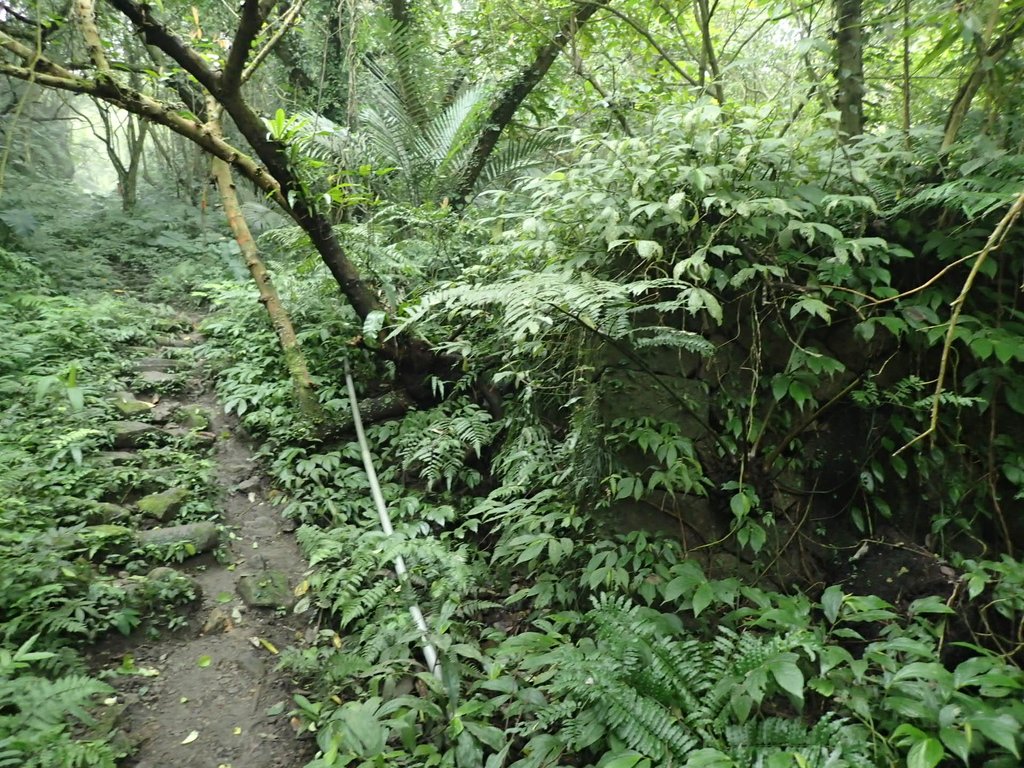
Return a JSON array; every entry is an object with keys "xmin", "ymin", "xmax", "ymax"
[{"xmin": 0, "ymin": 222, "xmax": 223, "ymax": 768}]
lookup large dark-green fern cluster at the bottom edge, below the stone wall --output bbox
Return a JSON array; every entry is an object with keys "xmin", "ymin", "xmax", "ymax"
[{"xmin": 509, "ymin": 598, "xmax": 874, "ymax": 768}]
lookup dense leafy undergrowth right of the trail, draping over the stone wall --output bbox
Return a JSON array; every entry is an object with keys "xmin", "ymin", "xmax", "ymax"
[{"xmin": 192, "ymin": 110, "xmax": 1024, "ymax": 768}]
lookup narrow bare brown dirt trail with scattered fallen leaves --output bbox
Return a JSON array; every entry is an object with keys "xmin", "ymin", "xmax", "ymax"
[{"xmin": 95, "ymin": 323, "xmax": 312, "ymax": 768}]
